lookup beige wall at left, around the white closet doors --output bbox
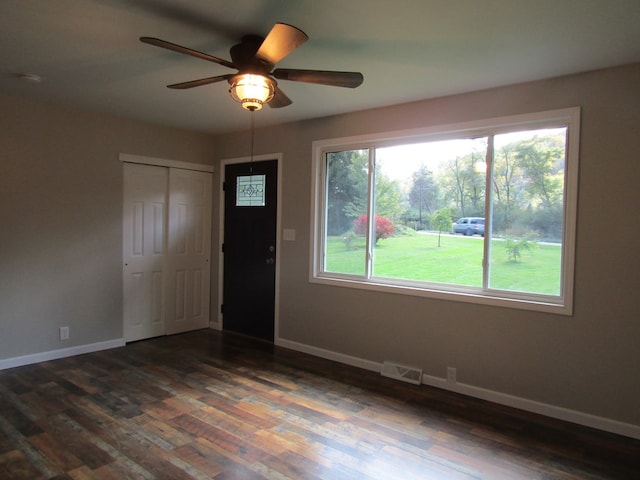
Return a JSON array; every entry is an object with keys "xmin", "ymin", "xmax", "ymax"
[{"xmin": 0, "ymin": 96, "xmax": 213, "ymax": 360}]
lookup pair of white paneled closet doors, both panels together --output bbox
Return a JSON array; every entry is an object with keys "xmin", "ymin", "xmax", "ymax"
[{"xmin": 123, "ymin": 163, "xmax": 211, "ymax": 342}]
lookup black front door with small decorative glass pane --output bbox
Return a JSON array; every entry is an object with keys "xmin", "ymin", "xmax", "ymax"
[{"xmin": 223, "ymin": 160, "xmax": 278, "ymax": 341}]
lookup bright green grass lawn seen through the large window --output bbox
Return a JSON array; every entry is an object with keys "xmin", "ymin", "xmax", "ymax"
[{"xmin": 327, "ymin": 234, "xmax": 561, "ymax": 295}]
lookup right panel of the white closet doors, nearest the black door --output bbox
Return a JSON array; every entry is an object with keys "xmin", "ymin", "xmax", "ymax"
[{"xmin": 165, "ymin": 168, "xmax": 212, "ymax": 334}]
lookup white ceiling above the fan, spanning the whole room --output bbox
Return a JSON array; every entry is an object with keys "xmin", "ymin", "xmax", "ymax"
[{"xmin": 0, "ymin": 0, "xmax": 640, "ymax": 132}]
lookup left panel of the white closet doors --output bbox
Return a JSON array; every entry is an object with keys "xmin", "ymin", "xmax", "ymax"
[{"xmin": 122, "ymin": 163, "xmax": 168, "ymax": 342}]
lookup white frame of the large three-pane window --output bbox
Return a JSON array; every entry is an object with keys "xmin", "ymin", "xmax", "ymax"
[{"xmin": 309, "ymin": 107, "xmax": 580, "ymax": 315}]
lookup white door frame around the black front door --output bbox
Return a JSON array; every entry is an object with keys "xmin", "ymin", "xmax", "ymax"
[{"xmin": 218, "ymin": 153, "xmax": 282, "ymax": 343}]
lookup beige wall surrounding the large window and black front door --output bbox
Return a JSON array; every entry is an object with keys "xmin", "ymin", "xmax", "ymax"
[{"xmin": 213, "ymin": 65, "xmax": 640, "ymax": 426}]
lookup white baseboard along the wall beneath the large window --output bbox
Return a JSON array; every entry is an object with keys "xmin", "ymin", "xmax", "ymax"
[{"xmin": 275, "ymin": 338, "xmax": 640, "ymax": 440}]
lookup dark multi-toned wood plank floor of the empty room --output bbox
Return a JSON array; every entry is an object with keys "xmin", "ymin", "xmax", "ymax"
[{"xmin": 0, "ymin": 330, "xmax": 640, "ymax": 480}]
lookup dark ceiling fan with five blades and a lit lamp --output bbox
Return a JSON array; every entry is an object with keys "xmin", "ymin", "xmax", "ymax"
[{"xmin": 140, "ymin": 23, "xmax": 364, "ymax": 111}]
